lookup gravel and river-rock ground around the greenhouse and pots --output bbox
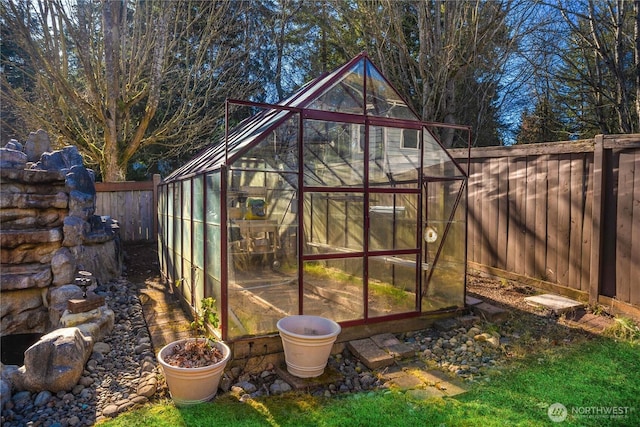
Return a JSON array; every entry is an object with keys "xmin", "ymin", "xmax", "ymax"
[{"xmin": 1, "ymin": 245, "xmax": 612, "ymax": 427}]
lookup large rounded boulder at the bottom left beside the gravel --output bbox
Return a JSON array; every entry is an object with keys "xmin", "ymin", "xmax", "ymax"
[{"xmin": 13, "ymin": 328, "xmax": 93, "ymax": 393}]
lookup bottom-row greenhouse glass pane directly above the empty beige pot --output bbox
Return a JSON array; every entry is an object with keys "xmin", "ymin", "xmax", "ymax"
[{"xmin": 303, "ymin": 258, "xmax": 364, "ymax": 322}]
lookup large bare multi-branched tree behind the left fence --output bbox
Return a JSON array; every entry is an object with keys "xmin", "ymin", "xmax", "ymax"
[{"xmin": 0, "ymin": 0, "xmax": 255, "ymax": 181}]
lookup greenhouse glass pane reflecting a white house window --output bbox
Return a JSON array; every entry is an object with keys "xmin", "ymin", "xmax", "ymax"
[{"xmin": 369, "ymin": 126, "xmax": 420, "ymax": 188}]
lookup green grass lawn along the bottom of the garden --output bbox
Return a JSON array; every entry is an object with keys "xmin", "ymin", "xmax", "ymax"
[{"xmin": 101, "ymin": 337, "xmax": 640, "ymax": 427}]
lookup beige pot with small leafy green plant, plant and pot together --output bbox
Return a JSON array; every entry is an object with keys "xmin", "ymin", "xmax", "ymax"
[{"xmin": 158, "ymin": 297, "xmax": 231, "ymax": 406}]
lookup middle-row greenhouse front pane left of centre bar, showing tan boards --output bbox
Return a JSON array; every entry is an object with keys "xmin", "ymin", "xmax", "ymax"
[{"xmin": 304, "ymin": 192, "xmax": 364, "ymax": 255}]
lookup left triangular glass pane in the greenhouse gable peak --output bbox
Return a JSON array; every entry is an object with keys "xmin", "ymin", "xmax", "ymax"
[{"xmin": 308, "ymin": 60, "xmax": 365, "ymax": 114}]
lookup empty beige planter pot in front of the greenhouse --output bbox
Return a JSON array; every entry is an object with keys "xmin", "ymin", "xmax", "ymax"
[{"xmin": 276, "ymin": 315, "xmax": 342, "ymax": 378}]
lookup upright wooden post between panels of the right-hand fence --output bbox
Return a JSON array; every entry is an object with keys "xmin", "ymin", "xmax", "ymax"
[{"xmin": 589, "ymin": 135, "xmax": 607, "ymax": 305}]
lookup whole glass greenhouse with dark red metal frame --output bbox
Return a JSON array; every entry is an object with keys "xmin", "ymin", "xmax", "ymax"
[{"xmin": 158, "ymin": 53, "xmax": 468, "ymax": 341}]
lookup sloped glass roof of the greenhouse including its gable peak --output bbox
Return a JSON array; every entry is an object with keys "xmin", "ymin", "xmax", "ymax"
[{"xmin": 165, "ymin": 52, "xmax": 436, "ymax": 182}]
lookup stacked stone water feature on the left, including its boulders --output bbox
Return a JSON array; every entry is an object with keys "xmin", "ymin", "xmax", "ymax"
[{"xmin": 0, "ymin": 130, "xmax": 122, "ymax": 403}]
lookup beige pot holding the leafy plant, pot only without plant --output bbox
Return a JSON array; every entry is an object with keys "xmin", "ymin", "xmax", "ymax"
[{"xmin": 158, "ymin": 338, "xmax": 231, "ymax": 406}]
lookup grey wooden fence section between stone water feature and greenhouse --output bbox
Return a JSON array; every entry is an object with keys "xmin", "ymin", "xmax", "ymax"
[{"xmin": 96, "ymin": 175, "xmax": 160, "ymax": 242}]
